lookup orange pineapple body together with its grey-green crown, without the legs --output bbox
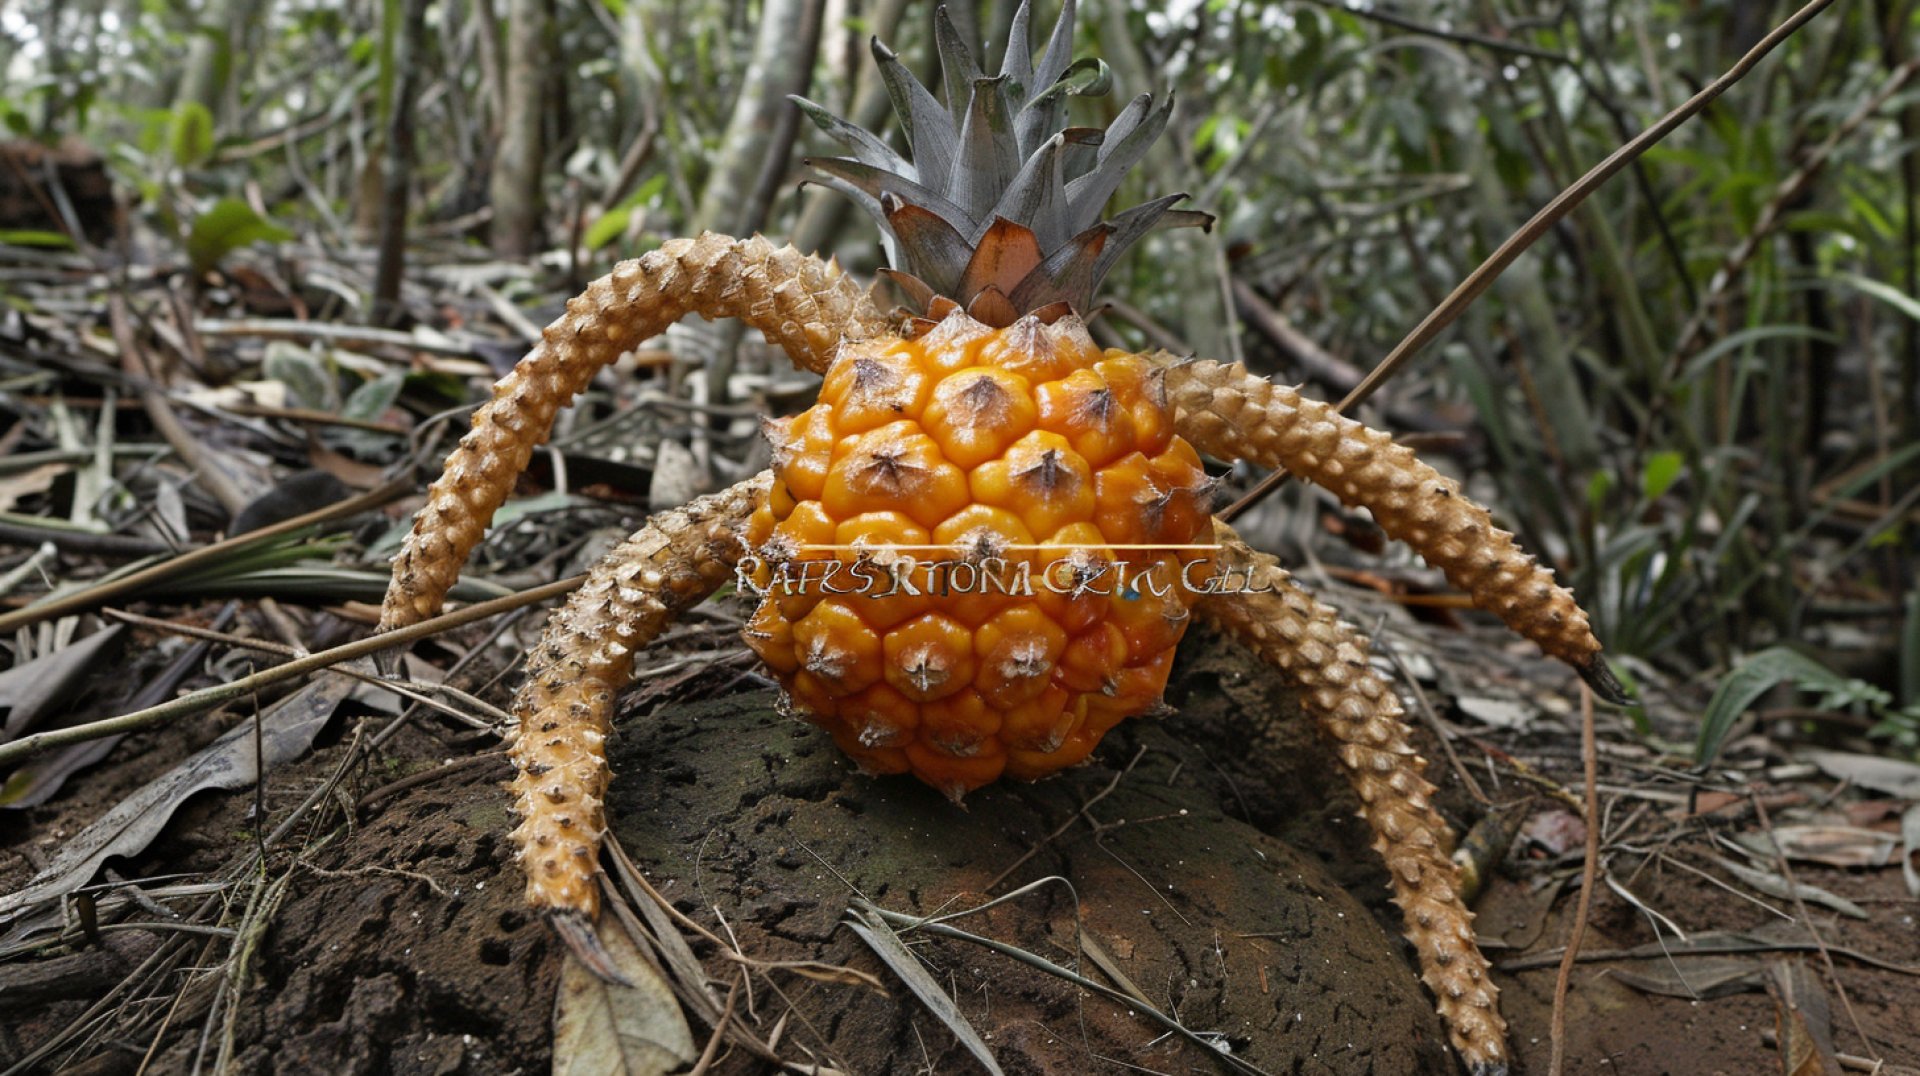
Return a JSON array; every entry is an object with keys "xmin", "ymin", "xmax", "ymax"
[{"xmin": 747, "ymin": 16, "xmax": 1212, "ymax": 799}]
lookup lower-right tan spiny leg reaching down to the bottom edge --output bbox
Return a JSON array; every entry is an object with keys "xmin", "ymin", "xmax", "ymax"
[{"xmin": 1196, "ymin": 523, "xmax": 1507, "ymax": 1076}]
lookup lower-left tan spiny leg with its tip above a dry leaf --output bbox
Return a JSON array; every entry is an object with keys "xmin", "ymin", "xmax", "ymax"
[{"xmin": 509, "ymin": 473, "xmax": 772, "ymax": 929}]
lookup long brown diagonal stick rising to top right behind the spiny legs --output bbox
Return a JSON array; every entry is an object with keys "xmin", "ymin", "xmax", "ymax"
[{"xmin": 1219, "ymin": 0, "xmax": 1834, "ymax": 523}]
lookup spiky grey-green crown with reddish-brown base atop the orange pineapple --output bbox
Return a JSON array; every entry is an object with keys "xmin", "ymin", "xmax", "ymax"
[{"xmin": 793, "ymin": 0, "xmax": 1213, "ymax": 327}]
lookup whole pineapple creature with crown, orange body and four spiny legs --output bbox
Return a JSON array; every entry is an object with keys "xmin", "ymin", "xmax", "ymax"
[{"xmin": 382, "ymin": 0, "xmax": 1620, "ymax": 1072}]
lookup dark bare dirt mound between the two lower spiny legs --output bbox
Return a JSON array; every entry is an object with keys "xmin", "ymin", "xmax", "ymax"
[{"xmin": 611, "ymin": 694, "xmax": 1452, "ymax": 1074}]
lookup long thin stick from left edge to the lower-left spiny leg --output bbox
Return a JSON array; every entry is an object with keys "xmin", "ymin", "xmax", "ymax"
[{"xmin": 0, "ymin": 575, "xmax": 588, "ymax": 767}]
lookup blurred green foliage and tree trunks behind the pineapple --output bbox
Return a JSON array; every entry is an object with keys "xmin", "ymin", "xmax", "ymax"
[{"xmin": 0, "ymin": 0, "xmax": 1920, "ymax": 749}]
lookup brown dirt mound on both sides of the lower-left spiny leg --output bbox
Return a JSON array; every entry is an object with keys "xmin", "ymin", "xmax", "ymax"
[{"xmin": 102, "ymin": 630, "xmax": 1452, "ymax": 1074}]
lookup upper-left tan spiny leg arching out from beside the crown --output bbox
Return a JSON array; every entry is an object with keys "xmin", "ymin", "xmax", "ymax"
[{"xmin": 380, "ymin": 232, "xmax": 891, "ymax": 630}]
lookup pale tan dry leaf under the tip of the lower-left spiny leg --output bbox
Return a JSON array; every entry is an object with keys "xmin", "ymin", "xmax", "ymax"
[{"xmin": 553, "ymin": 917, "xmax": 699, "ymax": 1076}]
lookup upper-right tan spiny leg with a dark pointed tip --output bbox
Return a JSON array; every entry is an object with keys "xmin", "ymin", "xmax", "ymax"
[{"xmin": 1162, "ymin": 355, "xmax": 1626, "ymax": 703}]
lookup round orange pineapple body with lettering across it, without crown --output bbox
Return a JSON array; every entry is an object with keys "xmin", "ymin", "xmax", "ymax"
[{"xmin": 747, "ymin": 309, "xmax": 1212, "ymax": 799}]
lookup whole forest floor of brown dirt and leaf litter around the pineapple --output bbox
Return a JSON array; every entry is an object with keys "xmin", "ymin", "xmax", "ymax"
[{"xmin": 0, "ymin": 228, "xmax": 1920, "ymax": 1074}]
